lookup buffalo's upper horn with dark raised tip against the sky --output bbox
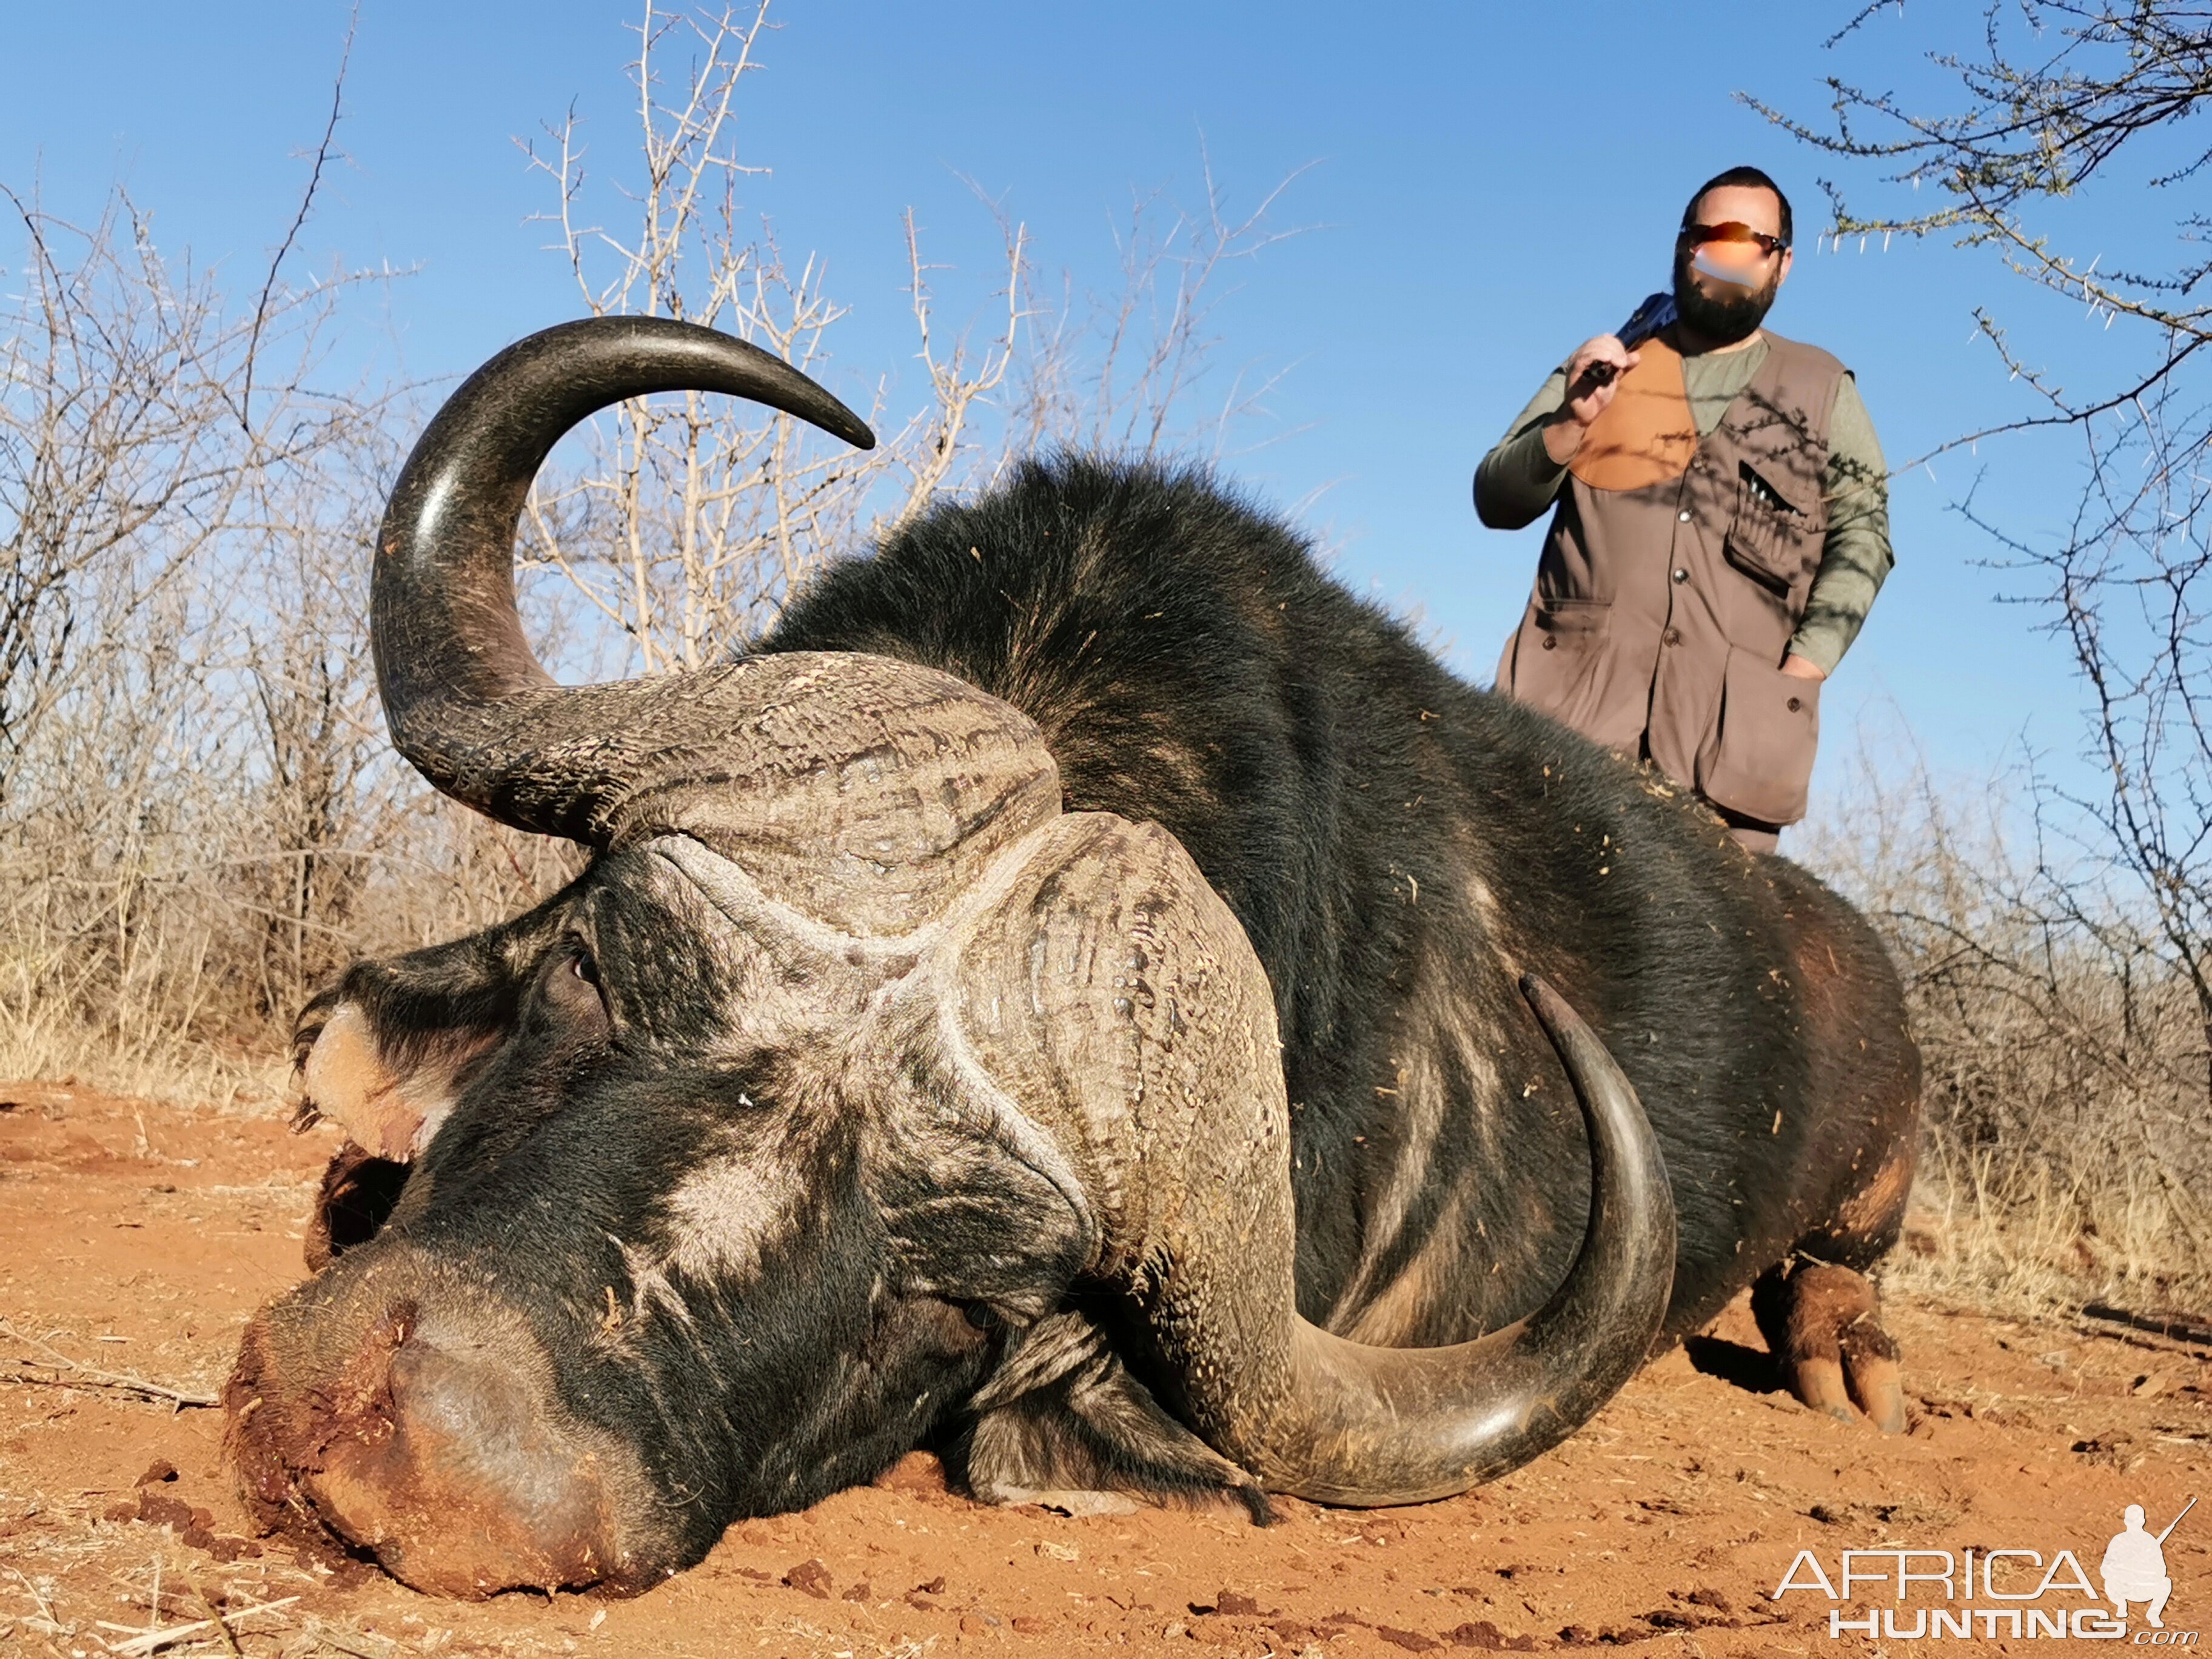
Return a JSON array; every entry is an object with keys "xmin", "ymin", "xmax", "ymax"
[{"xmin": 369, "ymin": 317, "xmax": 1059, "ymax": 931}]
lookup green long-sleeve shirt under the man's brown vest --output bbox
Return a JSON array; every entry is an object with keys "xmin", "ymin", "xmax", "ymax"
[{"xmin": 1475, "ymin": 338, "xmax": 1895, "ymax": 672}]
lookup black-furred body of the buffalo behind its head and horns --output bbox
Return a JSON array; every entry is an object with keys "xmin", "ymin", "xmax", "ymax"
[{"xmin": 761, "ymin": 458, "xmax": 1918, "ymax": 1342}]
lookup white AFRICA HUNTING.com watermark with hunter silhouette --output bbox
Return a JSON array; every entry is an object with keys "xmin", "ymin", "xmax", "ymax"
[{"xmin": 1772, "ymin": 1498, "xmax": 2199, "ymax": 1648}]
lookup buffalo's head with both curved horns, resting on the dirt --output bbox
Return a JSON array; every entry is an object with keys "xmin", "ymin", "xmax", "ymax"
[{"xmin": 228, "ymin": 318, "xmax": 1675, "ymax": 1595}]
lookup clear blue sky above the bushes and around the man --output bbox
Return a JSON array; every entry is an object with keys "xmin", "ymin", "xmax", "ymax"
[{"xmin": 0, "ymin": 0, "xmax": 2163, "ymax": 818}]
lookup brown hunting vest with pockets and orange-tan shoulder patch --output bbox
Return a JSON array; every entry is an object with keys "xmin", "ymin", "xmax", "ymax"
[{"xmin": 1498, "ymin": 334, "xmax": 1847, "ymax": 825}]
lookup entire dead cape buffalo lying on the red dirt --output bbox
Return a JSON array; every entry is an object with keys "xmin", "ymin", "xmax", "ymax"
[{"xmin": 228, "ymin": 318, "xmax": 1918, "ymax": 1595}]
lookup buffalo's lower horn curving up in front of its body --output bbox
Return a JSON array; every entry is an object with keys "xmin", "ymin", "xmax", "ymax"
[{"xmin": 951, "ymin": 814, "xmax": 1675, "ymax": 1504}]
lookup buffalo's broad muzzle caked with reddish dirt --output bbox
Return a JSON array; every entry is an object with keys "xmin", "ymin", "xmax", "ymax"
[{"xmin": 228, "ymin": 1274, "xmax": 652, "ymax": 1597}]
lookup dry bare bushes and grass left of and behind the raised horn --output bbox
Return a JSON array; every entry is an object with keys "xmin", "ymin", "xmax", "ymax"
[{"xmin": 0, "ymin": 0, "xmax": 1274, "ymax": 1119}]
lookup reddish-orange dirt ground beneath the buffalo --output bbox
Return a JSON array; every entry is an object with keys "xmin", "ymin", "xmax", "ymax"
[{"xmin": 0, "ymin": 1084, "xmax": 2212, "ymax": 1659}]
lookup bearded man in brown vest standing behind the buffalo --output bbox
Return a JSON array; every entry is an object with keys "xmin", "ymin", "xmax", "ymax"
[{"xmin": 1475, "ymin": 168, "xmax": 1891, "ymax": 851}]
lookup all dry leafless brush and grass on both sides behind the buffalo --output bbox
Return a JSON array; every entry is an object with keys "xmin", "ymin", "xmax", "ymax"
[{"xmin": 0, "ymin": 11, "xmax": 2212, "ymax": 1310}]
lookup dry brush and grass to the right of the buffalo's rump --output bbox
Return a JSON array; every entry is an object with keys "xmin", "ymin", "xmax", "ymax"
[{"xmin": 1798, "ymin": 739, "xmax": 2212, "ymax": 1312}]
